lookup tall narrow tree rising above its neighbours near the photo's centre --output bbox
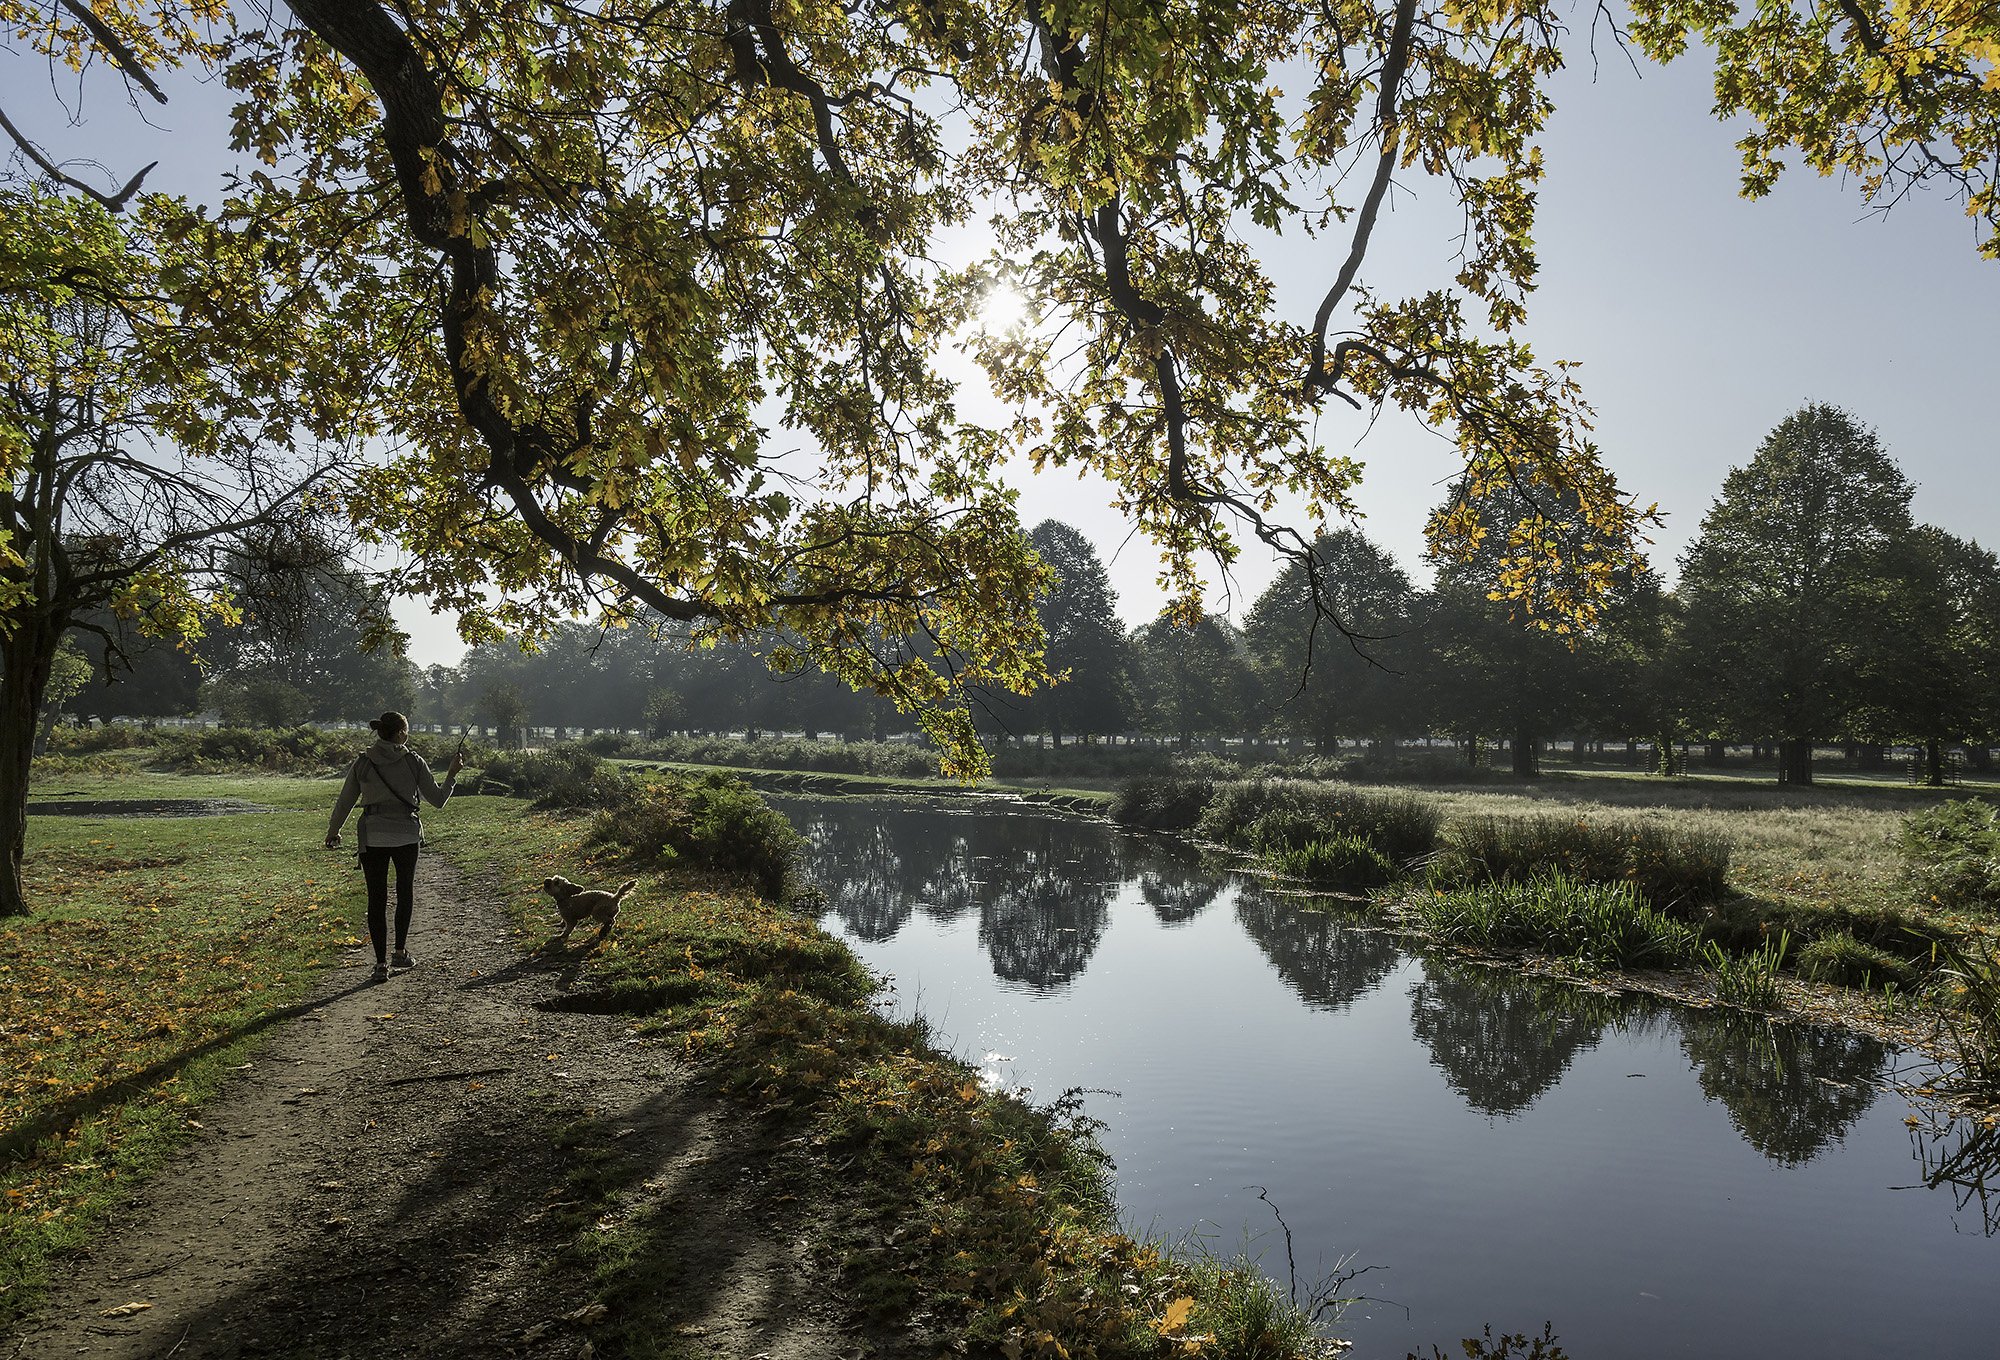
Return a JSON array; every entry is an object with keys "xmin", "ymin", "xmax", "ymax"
[{"xmin": 1028, "ymin": 520, "xmax": 1132, "ymax": 746}]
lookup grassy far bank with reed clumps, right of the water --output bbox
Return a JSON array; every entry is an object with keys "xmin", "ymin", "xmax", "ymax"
[{"xmin": 1114, "ymin": 774, "xmax": 2000, "ymax": 1100}]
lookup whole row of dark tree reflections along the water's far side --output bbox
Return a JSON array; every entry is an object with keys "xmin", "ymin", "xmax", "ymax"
[{"xmin": 788, "ymin": 802, "xmax": 1888, "ymax": 1152}]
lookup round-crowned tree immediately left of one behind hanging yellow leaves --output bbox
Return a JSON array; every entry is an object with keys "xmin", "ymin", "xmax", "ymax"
[{"xmin": 1244, "ymin": 530, "xmax": 1420, "ymax": 750}]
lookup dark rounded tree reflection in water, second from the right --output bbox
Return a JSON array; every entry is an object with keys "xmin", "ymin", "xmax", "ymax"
[{"xmin": 1410, "ymin": 962, "xmax": 1622, "ymax": 1118}]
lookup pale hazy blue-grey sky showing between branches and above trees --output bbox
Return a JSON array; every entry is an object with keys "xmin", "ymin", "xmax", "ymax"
[{"xmin": 0, "ymin": 27, "xmax": 2000, "ymax": 664}]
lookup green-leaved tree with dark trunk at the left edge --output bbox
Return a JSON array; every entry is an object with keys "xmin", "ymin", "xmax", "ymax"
[{"xmin": 0, "ymin": 186, "xmax": 338, "ymax": 916}]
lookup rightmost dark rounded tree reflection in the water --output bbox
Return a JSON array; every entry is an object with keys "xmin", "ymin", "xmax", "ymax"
[{"xmin": 1680, "ymin": 1012, "xmax": 1888, "ymax": 1166}]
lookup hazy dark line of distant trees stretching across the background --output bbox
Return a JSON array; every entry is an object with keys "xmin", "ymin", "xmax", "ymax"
[{"xmin": 72, "ymin": 406, "xmax": 2000, "ymax": 782}]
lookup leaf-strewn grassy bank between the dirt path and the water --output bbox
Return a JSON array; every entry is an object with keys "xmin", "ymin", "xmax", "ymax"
[{"xmin": 454, "ymin": 792, "xmax": 1340, "ymax": 1360}]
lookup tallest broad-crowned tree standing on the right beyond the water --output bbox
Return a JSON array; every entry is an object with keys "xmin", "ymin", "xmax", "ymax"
[{"xmin": 1680, "ymin": 404, "xmax": 1912, "ymax": 784}]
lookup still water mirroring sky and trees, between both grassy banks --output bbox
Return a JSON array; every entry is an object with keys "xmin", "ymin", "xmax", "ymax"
[{"xmin": 774, "ymin": 798, "xmax": 2000, "ymax": 1360}]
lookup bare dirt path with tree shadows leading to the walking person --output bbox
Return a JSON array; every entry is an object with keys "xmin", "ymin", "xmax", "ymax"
[{"xmin": 0, "ymin": 856, "xmax": 870, "ymax": 1360}]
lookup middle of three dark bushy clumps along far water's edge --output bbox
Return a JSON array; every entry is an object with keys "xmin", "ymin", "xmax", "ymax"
[{"xmin": 1200, "ymin": 780, "xmax": 1440, "ymax": 864}]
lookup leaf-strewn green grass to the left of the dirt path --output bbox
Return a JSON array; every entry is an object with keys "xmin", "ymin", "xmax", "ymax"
[{"xmin": 0, "ymin": 778, "xmax": 360, "ymax": 1320}]
